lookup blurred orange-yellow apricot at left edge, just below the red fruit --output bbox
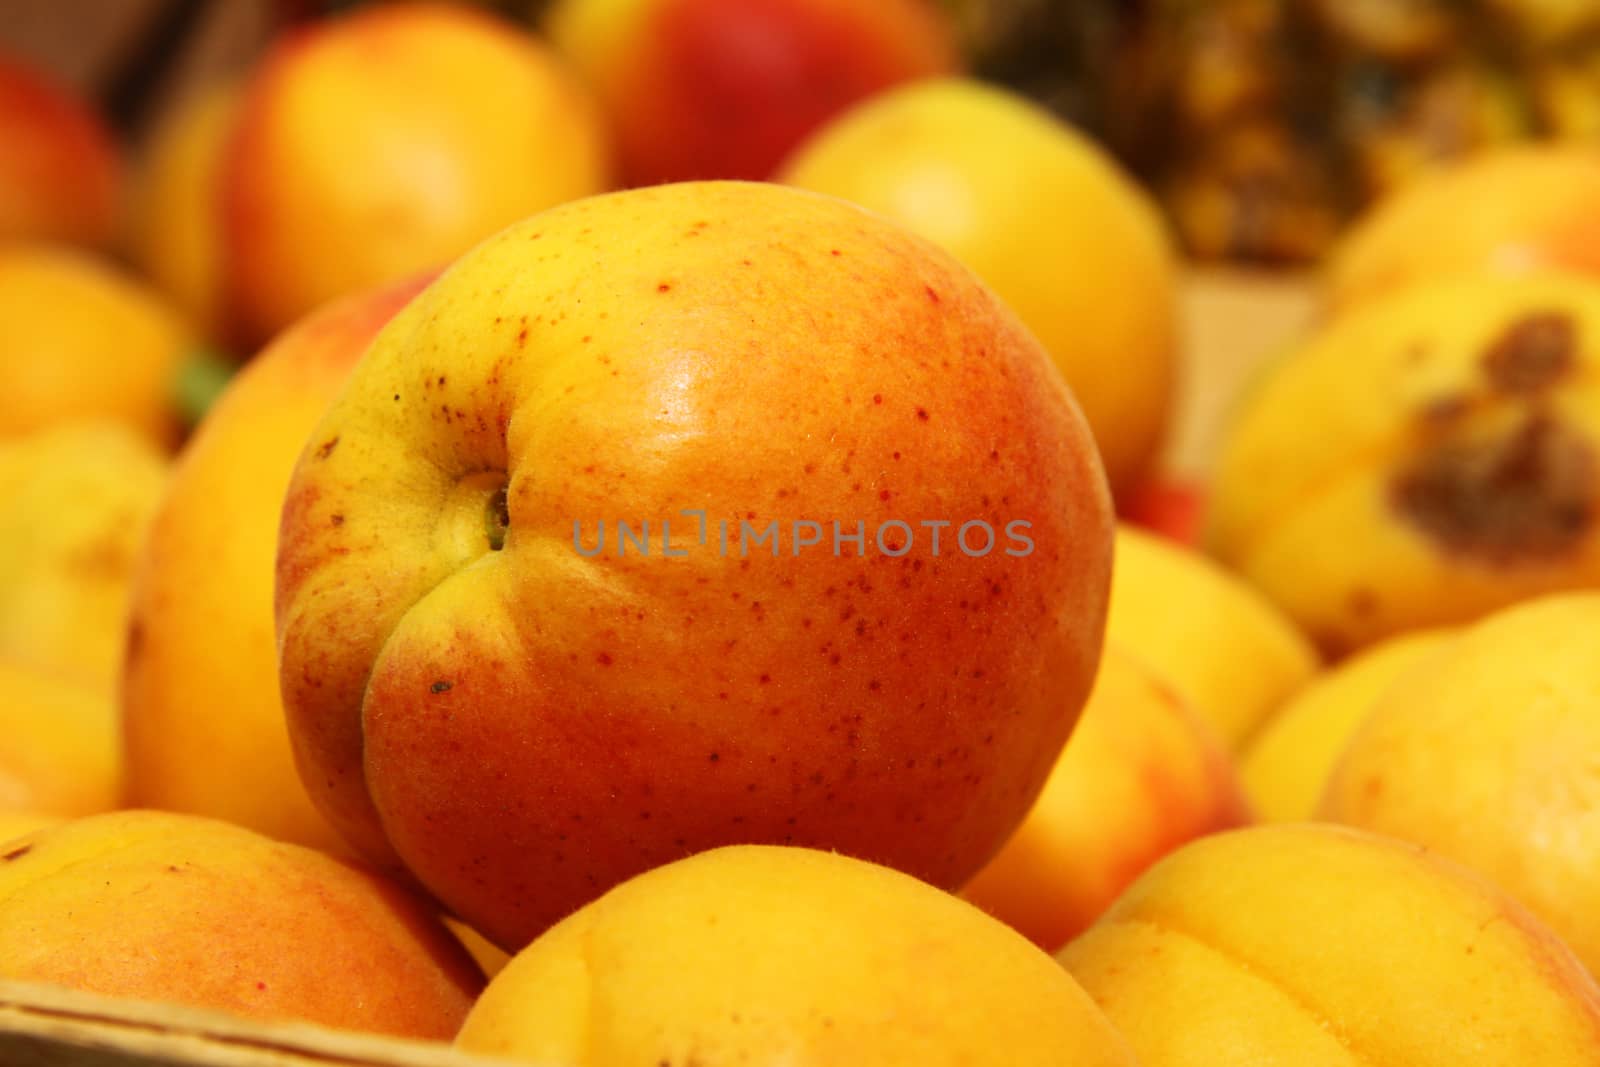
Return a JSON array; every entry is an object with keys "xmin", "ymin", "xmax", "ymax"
[{"xmin": 0, "ymin": 242, "xmax": 194, "ymax": 446}]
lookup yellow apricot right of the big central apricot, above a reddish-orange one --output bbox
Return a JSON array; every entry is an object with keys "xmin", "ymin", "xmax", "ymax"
[{"xmin": 1106, "ymin": 525, "xmax": 1318, "ymax": 750}]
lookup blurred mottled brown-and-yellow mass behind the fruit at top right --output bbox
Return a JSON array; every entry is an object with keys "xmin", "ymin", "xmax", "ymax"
[{"xmin": 947, "ymin": 0, "xmax": 1600, "ymax": 262}]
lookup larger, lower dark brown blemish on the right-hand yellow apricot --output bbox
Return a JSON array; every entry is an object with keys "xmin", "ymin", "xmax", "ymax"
[{"xmin": 1389, "ymin": 413, "xmax": 1595, "ymax": 566}]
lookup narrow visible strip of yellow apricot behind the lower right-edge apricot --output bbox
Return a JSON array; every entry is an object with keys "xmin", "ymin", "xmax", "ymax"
[{"xmin": 1238, "ymin": 630, "xmax": 1456, "ymax": 822}]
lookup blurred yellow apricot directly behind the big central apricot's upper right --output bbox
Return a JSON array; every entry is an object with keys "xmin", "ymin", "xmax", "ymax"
[{"xmin": 778, "ymin": 78, "xmax": 1178, "ymax": 494}]
